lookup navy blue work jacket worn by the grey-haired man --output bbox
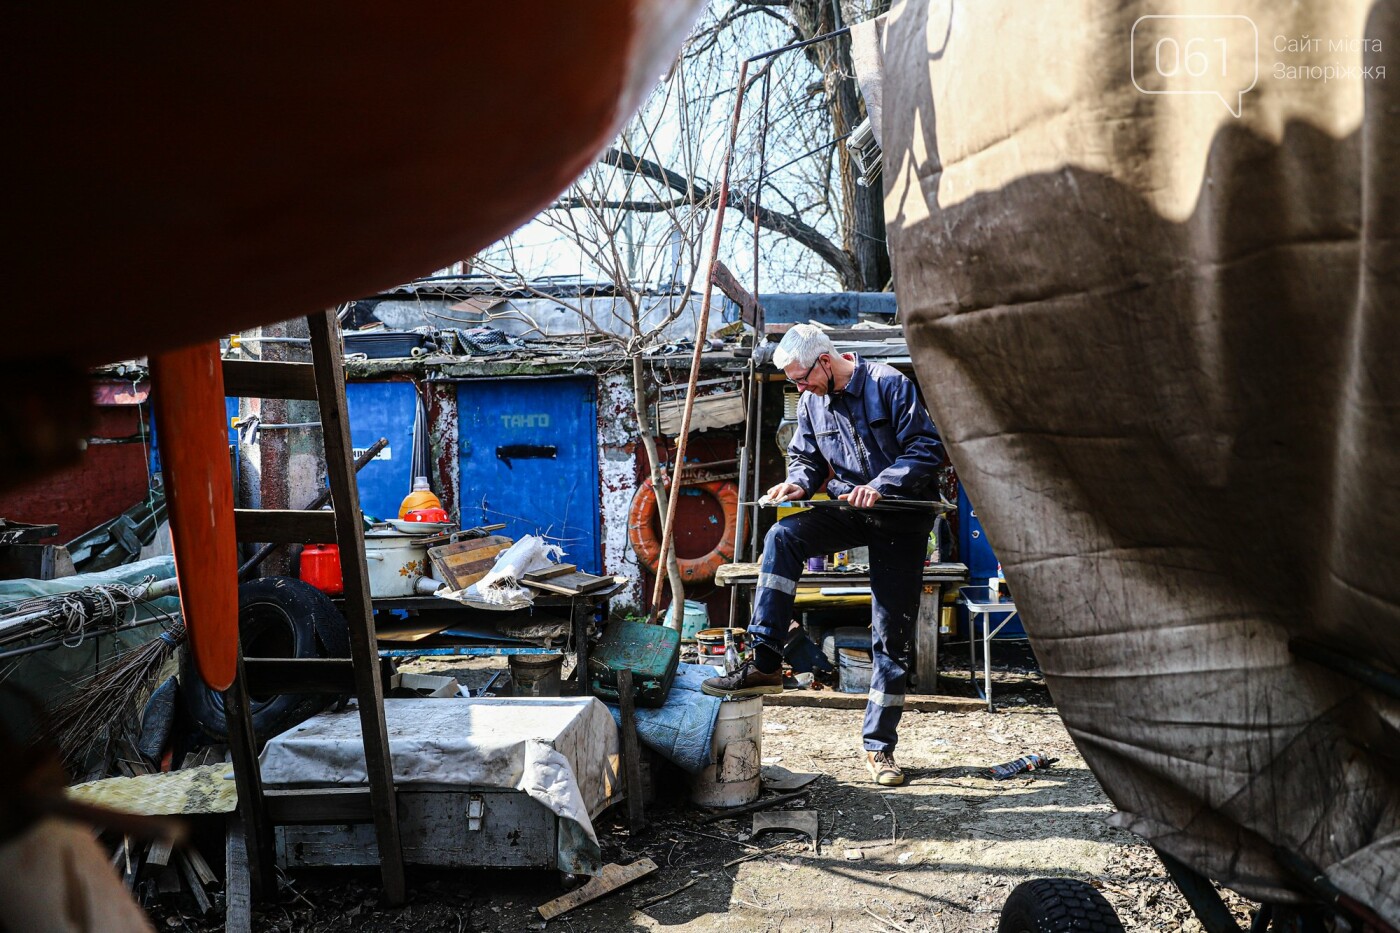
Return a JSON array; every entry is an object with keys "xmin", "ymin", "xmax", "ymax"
[{"xmin": 787, "ymin": 356, "xmax": 944, "ymax": 499}]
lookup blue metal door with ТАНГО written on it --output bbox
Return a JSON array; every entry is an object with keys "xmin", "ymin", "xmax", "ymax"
[{"xmin": 456, "ymin": 377, "xmax": 602, "ymax": 573}]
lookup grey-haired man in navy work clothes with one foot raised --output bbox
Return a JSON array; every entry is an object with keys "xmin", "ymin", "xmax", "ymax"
[{"xmin": 703, "ymin": 324, "xmax": 942, "ymax": 786}]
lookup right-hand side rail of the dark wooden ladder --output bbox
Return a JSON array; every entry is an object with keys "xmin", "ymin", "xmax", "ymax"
[{"xmin": 307, "ymin": 310, "xmax": 407, "ymax": 905}]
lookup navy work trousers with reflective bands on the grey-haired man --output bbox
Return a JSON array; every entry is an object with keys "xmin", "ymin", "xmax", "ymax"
[{"xmin": 749, "ymin": 507, "xmax": 934, "ymax": 751}]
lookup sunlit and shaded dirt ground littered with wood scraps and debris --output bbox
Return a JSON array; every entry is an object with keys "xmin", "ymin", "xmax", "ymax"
[{"xmin": 144, "ymin": 650, "xmax": 1249, "ymax": 933}]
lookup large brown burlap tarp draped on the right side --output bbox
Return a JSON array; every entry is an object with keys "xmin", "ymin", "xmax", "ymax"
[{"xmin": 882, "ymin": 0, "xmax": 1400, "ymax": 923}]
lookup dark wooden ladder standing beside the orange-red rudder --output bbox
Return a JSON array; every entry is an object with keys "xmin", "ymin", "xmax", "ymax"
[{"xmin": 224, "ymin": 311, "xmax": 405, "ymax": 907}]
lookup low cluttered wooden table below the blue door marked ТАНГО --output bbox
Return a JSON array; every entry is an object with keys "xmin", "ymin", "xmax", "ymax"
[{"xmin": 338, "ymin": 581, "xmax": 626, "ymax": 696}]
